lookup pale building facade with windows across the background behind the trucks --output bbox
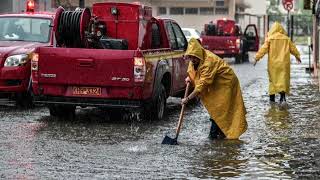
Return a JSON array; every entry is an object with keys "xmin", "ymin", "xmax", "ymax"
[{"xmin": 0, "ymin": 0, "xmax": 250, "ymax": 31}]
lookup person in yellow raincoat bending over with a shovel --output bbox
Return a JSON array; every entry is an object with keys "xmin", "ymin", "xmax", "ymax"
[{"xmin": 181, "ymin": 38, "xmax": 247, "ymax": 139}]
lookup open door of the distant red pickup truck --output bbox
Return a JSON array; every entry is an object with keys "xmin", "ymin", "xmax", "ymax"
[{"xmin": 244, "ymin": 24, "xmax": 259, "ymax": 51}]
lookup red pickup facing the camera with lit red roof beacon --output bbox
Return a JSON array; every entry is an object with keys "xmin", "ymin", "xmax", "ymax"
[{"xmin": 0, "ymin": 9, "xmax": 54, "ymax": 107}]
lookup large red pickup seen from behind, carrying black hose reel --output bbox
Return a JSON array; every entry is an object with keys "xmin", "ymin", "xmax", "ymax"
[{"xmin": 32, "ymin": 2, "xmax": 189, "ymax": 119}]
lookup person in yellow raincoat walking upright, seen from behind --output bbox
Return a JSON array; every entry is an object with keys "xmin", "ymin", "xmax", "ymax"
[{"xmin": 254, "ymin": 22, "xmax": 301, "ymax": 103}]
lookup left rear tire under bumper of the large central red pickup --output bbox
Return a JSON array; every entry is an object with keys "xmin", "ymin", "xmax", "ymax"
[{"xmin": 48, "ymin": 104, "xmax": 76, "ymax": 119}]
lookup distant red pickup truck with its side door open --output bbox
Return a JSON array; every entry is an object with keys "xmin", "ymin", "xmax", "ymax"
[{"xmin": 201, "ymin": 19, "xmax": 259, "ymax": 63}]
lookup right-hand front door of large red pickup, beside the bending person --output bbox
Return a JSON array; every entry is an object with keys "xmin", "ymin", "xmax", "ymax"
[{"xmin": 166, "ymin": 21, "xmax": 189, "ymax": 92}]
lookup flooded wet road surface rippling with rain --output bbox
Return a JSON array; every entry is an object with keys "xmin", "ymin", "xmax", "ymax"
[{"xmin": 0, "ymin": 54, "xmax": 320, "ymax": 179}]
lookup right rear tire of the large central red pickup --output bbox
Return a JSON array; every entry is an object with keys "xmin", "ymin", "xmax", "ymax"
[{"xmin": 142, "ymin": 84, "xmax": 167, "ymax": 121}]
